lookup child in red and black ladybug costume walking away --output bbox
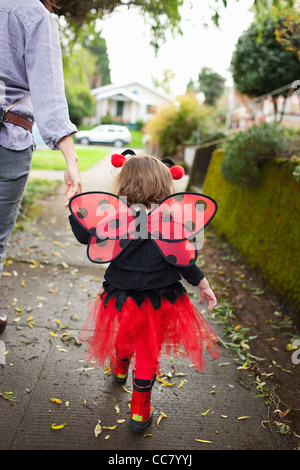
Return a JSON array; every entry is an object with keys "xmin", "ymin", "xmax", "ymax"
[{"xmin": 69, "ymin": 150, "xmax": 219, "ymax": 432}]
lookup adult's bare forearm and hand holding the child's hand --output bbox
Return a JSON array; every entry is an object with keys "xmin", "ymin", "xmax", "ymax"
[{"xmin": 58, "ymin": 135, "xmax": 82, "ymax": 206}]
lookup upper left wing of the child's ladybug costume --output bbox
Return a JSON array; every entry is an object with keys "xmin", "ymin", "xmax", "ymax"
[{"xmin": 69, "ymin": 191, "xmax": 135, "ymax": 239}]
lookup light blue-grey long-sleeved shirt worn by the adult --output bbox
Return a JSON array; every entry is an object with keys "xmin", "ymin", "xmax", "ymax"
[{"xmin": 0, "ymin": 0, "xmax": 77, "ymax": 150}]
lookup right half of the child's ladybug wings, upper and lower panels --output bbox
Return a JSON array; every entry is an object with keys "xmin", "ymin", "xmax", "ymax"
[{"xmin": 148, "ymin": 193, "xmax": 217, "ymax": 266}]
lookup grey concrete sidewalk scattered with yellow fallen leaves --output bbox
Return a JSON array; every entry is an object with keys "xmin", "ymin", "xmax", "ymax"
[{"xmin": 0, "ymin": 151, "xmax": 296, "ymax": 456}]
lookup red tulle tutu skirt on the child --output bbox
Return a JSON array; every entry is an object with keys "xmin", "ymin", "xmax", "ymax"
[{"xmin": 79, "ymin": 290, "xmax": 219, "ymax": 373}]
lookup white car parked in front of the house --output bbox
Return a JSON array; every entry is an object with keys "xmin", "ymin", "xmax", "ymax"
[{"xmin": 75, "ymin": 124, "xmax": 131, "ymax": 147}]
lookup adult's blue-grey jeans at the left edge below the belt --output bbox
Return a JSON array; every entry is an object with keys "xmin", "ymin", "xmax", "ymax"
[{"xmin": 0, "ymin": 145, "xmax": 32, "ymax": 277}]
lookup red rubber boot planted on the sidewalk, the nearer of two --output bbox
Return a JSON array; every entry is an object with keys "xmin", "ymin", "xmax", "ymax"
[{"xmin": 130, "ymin": 375, "xmax": 156, "ymax": 432}]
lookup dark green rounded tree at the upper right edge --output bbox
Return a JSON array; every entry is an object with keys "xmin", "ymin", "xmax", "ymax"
[{"xmin": 231, "ymin": 17, "xmax": 300, "ymax": 96}]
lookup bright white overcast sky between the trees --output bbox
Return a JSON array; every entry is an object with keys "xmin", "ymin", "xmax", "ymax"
[{"xmin": 99, "ymin": 0, "xmax": 253, "ymax": 95}]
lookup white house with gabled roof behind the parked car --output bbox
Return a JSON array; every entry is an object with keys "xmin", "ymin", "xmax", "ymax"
[{"xmin": 91, "ymin": 82, "xmax": 172, "ymax": 125}]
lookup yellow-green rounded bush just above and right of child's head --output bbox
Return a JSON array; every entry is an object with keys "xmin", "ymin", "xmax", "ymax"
[{"xmin": 145, "ymin": 93, "xmax": 211, "ymax": 157}]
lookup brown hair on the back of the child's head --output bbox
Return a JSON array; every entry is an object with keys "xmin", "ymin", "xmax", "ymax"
[{"xmin": 116, "ymin": 155, "xmax": 173, "ymax": 207}]
